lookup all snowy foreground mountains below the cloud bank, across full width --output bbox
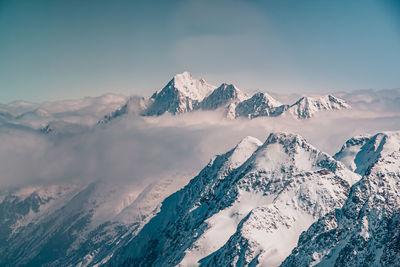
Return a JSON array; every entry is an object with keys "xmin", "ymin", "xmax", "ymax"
[{"xmin": 0, "ymin": 129, "xmax": 400, "ymax": 266}]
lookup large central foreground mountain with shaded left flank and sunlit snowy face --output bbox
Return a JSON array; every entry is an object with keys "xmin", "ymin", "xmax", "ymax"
[{"xmin": 109, "ymin": 133, "xmax": 359, "ymax": 266}]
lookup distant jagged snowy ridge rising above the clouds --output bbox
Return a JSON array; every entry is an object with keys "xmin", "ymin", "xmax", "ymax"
[{"xmin": 100, "ymin": 72, "xmax": 350, "ymax": 123}]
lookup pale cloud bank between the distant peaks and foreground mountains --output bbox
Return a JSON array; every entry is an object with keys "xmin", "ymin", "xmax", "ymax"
[{"xmin": 0, "ymin": 104, "xmax": 400, "ymax": 192}]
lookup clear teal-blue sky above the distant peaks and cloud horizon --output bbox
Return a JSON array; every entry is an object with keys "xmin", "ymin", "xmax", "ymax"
[{"xmin": 0, "ymin": 0, "xmax": 400, "ymax": 103}]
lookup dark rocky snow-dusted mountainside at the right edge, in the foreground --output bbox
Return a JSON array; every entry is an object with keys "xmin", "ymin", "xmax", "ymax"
[{"xmin": 282, "ymin": 132, "xmax": 400, "ymax": 266}]
